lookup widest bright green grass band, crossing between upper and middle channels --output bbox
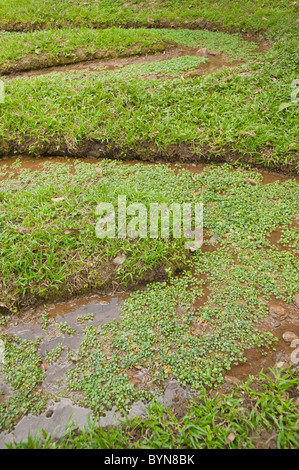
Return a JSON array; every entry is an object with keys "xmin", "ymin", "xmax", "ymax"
[{"xmin": 0, "ymin": 43, "xmax": 298, "ymax": 169}]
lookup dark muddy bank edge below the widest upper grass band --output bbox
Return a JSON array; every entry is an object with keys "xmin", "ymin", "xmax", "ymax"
[{"xmin": 0, "ymin": 142, "xmax": 299, "ymax": 176}]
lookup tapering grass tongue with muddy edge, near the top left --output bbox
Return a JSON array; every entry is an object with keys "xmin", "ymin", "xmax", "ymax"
[{"xmin": 0, "ymin": 28, "xmax": 169, "ymax": 73}]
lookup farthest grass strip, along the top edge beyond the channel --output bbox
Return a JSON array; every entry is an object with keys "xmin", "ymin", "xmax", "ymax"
[{"xmin": 0, "ymin": 0, "xmax": 297, "ymax": 31}]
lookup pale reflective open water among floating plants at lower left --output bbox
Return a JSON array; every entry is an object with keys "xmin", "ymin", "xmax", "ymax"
[{"xmin": 0, "ymin": 292, "xmax": 196, "ymax": 448}]
